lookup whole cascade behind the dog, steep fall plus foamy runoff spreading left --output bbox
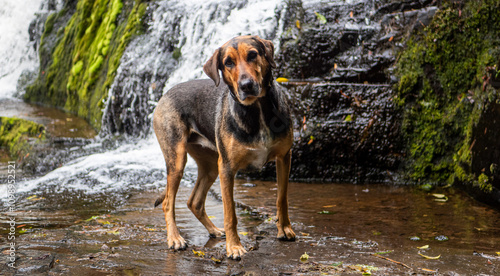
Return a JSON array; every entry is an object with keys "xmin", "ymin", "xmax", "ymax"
[{"xmin": 0, "ymin": 0, "xmax": 283, "ymax": 197}]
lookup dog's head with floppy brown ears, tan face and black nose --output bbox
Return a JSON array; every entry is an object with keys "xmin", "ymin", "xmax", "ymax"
[{"xmin": 203, "ymin": 36, "xmax": 276, "ymax": 105}]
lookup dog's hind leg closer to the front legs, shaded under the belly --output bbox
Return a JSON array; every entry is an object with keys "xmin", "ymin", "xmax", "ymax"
[{"xmin": 187, "ymin": 144, "xmax": 224, "ymax": 237}]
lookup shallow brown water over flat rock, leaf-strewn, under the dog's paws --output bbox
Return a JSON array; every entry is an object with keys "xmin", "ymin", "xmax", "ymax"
[{"xmin": 0, "ymin": 178, "xmax": 500, "ymax": 275}]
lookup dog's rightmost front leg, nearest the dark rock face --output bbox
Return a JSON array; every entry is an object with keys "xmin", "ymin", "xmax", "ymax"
[{"xmin": 276, "ymin": 151, "xmax": 295, "ymax": 241}]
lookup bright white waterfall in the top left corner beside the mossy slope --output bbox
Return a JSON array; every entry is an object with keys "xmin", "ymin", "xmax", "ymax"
[{"xmin": 0, "ymin": 0, "xmax": 43, "ymax": 98}]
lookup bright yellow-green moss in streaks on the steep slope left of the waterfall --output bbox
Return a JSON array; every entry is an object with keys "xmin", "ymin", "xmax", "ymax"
[{"xmin": 25, "ymin": 0, "xmax": 146, "ymax": 129}]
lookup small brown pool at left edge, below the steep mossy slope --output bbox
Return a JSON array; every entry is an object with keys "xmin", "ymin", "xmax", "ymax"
[{"xmin": 0, "ymin": 99, "xmax": 97, "ymax": 138}]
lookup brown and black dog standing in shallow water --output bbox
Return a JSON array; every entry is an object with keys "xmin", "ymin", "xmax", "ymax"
[{"xmin": 153, "ymin": 36, "xmax": 295, "ymax": 259}]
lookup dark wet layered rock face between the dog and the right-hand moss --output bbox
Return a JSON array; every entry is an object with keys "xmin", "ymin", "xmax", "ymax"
[{"xmin": 243, "ymin": 1, "xmax": 437, "ymax": 183}]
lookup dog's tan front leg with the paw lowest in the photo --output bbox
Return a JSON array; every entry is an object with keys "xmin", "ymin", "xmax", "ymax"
[{"xmin": 219, "ymin": 157, "xmax": 247, "ymax": 260}]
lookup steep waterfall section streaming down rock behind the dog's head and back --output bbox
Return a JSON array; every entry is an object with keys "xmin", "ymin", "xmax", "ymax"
[{"xmin": 102, "ymin": 0, "xmax": 283, "ymax": 136}]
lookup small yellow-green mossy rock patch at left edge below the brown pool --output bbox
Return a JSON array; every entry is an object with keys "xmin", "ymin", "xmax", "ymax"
[{"xmin": 0, "ymin": 117, "xmax": 45, "ymax": 158}]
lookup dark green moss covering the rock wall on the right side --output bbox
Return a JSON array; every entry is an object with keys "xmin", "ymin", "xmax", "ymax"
[{"xmin": 395, "ymin": 0, "xmax": 500, "ymax": 183}]
